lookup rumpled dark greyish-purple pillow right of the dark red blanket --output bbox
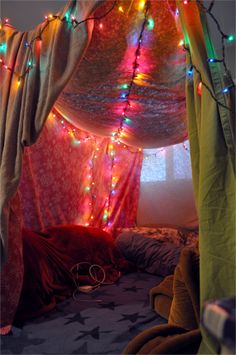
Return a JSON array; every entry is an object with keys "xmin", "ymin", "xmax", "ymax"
[{"xmin": 116, "ymin": 232, "xmax": 183, "ymax": 276}]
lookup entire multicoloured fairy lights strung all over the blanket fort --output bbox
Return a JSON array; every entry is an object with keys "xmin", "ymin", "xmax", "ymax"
[{"xmin": 0, "ymin": 0, "xmax": 235, "ymax": 229}]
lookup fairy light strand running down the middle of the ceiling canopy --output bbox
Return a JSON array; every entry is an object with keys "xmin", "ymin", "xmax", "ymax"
[{"xmin": 111, "ymin": 1, "xmax": 150, "ymax": 142}]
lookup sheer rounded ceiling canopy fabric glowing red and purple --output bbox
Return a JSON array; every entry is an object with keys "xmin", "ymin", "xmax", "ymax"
[{"xmin": 56, "ymin": 0, "xmax": 187, "ymax": 148}]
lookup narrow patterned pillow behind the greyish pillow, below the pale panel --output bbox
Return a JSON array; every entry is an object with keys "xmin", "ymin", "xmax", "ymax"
[{"xmin": 118, "ymin": 226, "xmax": 198, "ymax": 246}]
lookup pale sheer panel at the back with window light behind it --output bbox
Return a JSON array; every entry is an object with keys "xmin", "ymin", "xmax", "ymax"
[{"xmin": 137, "ymin": 141, "xmax": 198, "ymax": 228}]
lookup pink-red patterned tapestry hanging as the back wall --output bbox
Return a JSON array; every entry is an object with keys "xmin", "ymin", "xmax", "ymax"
[{"xmin": 19, "ymin": 114, "xmax": 142, "ymax": 231}]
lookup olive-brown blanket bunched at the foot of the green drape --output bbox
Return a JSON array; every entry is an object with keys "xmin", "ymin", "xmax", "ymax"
[{"xmin": 123, "ymin": 247, "xmax": 201, "ymax": 354}]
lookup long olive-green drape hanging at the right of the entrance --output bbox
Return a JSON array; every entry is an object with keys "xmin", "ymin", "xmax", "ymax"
[{"xmin": 179, "ymin": 1, "xmax": 236, "ymax": 354}]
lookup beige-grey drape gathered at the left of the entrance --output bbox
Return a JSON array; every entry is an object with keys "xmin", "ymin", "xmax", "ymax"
[{"xmin": 0, "ymin": 0, "xmax": 101, "ymax": 268}]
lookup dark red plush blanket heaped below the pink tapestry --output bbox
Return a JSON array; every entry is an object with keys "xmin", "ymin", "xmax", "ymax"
[{"xmin": 15, "ymin": 225, "xmax": 130, "ymax": 321}]
